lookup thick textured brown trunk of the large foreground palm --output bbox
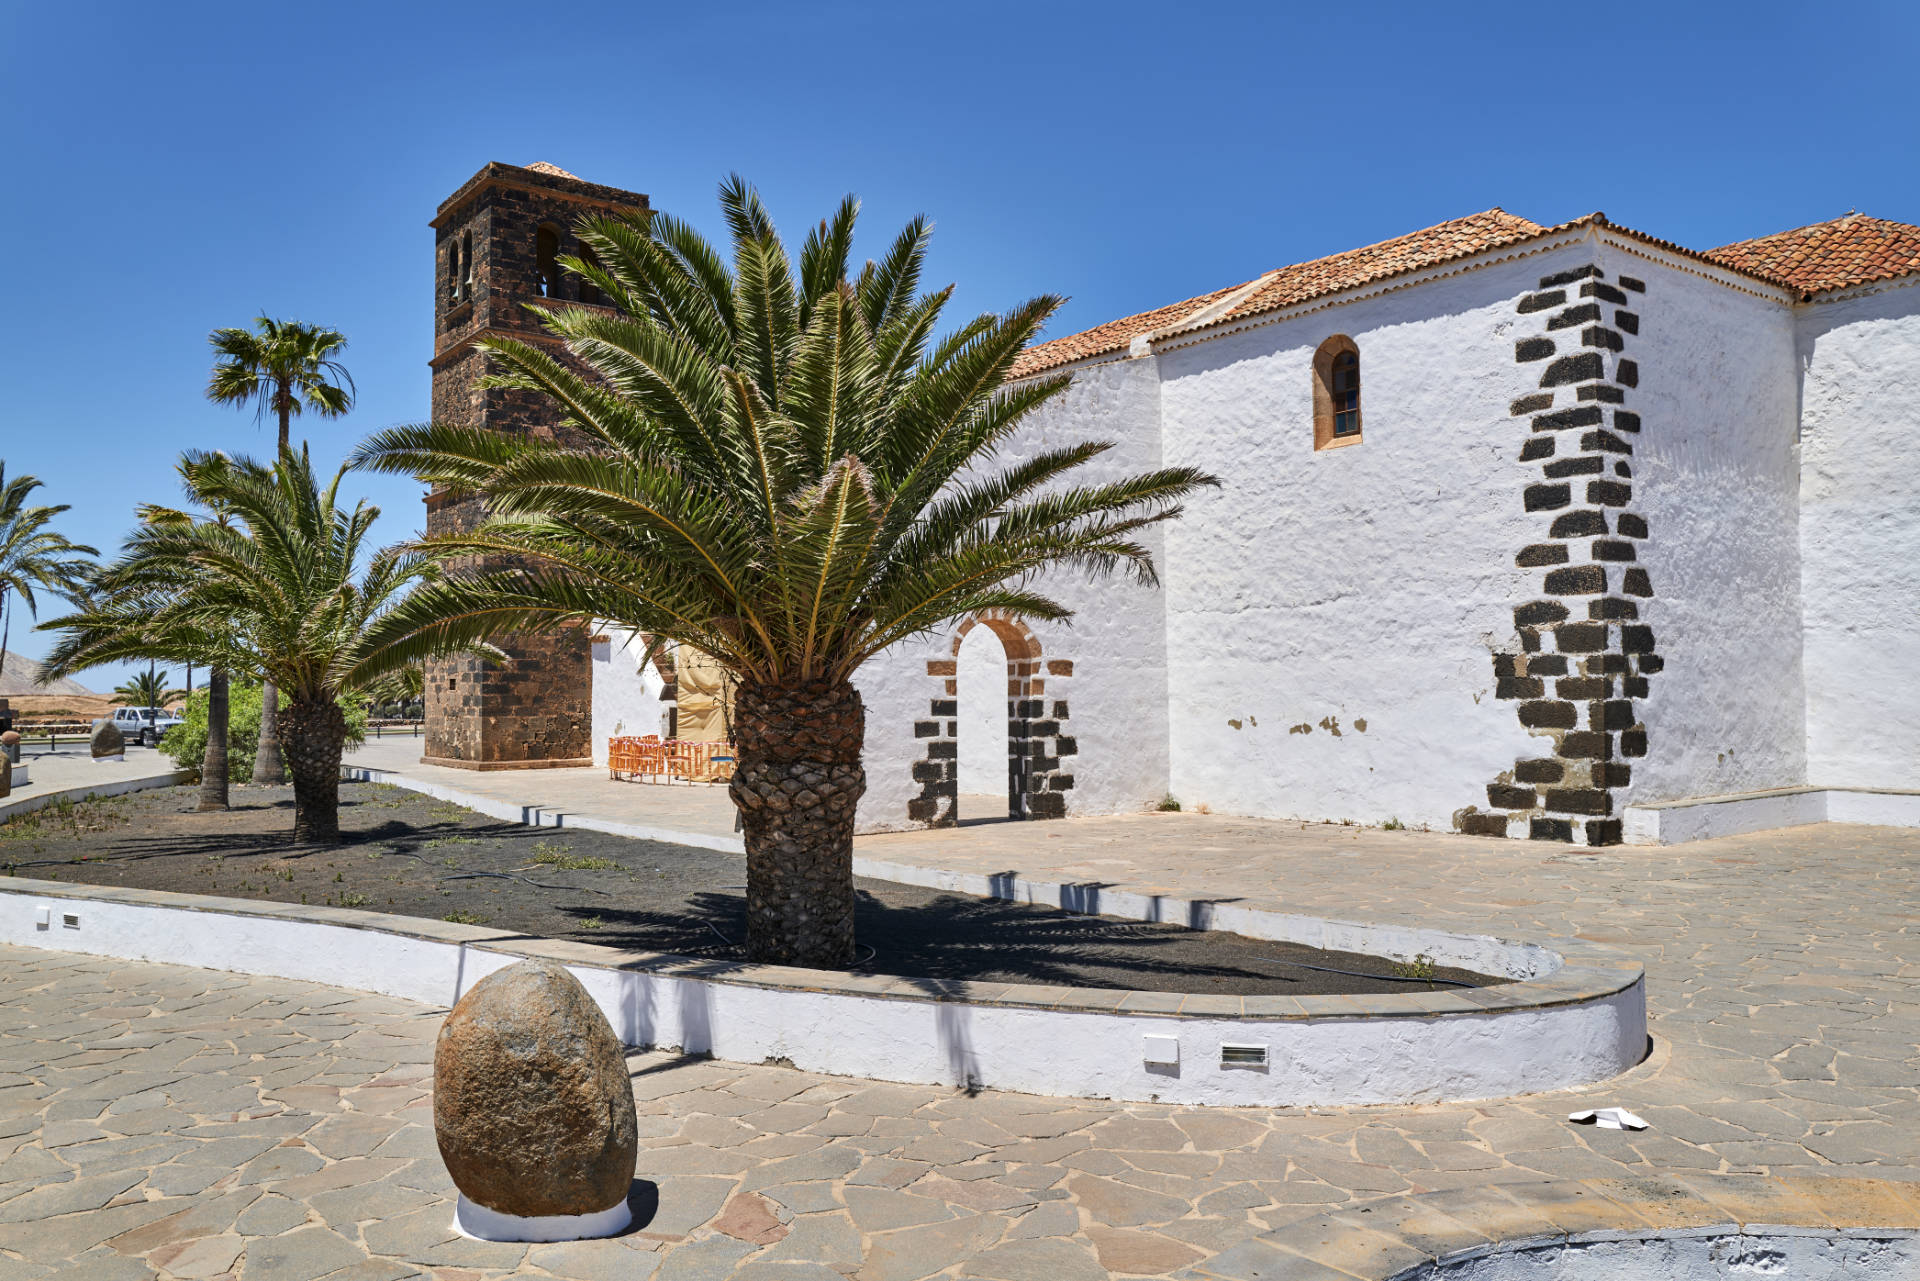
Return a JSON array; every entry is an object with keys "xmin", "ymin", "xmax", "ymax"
[{"xmin": 730, "ymin": 680, "xmax": 866, "ymax": 970}]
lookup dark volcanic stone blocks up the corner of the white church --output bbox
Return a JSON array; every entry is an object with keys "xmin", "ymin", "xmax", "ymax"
[{"xmin": 1455, "ymin": 265, "xmax": 1661, "ymax": 845}]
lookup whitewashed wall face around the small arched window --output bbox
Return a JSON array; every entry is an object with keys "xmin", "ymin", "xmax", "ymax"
[{"xmin": 1136, "ymin": 248, "xmax": 1586, "ymax": 828}]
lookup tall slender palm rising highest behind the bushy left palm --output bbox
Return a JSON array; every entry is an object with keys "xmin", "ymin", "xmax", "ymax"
[{"xmin": 207, "ymin": 315, "xmax": 355, "ymax": 784}]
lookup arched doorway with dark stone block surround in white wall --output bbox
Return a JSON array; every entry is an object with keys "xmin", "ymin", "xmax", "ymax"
[{"xmin": 906, "ymin": 609, "xmax": 1079, "ymax": 828}]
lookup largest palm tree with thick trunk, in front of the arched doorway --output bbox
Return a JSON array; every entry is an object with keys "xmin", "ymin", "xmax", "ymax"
[{"xmin": 353, "ymin": 177, "xmax": 1213, "ymax": 966}]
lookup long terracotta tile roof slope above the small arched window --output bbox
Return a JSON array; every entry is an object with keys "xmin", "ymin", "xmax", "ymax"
[{"xmin": 1012, "ymin": 209, "xmax": 1548, "ymax": 378}]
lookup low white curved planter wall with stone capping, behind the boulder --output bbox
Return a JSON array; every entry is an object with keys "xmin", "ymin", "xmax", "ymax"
[{"xmin": 0, "ymin": 878, "xmax": 1647, "ymax": 1106}]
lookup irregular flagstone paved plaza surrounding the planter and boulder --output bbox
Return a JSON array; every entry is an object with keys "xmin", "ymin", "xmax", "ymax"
[{"xmin": 0, "ymin": 814, "xmax": 1920, "ymax": 1281}]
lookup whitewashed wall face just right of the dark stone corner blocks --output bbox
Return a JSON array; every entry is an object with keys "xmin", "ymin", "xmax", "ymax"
[{"xmin": 1601, "ymin": 250, "xmax": 1807, "ymax": 801}]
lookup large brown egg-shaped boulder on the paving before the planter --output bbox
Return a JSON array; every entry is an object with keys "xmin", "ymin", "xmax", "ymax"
[{"xmin": 434, "ymin": 960, "xmax": 639, "ymax": 1218}]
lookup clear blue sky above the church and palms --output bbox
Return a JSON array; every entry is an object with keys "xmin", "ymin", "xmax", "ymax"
[{"xmin": 0, "ymin": 0, "xmax": 1920, "ymax": 688}]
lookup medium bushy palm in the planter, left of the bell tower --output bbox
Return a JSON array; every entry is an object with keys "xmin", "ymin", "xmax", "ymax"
[{"xmin": 42, "ymin": 449, "xmax": 432, "ymax": 841}]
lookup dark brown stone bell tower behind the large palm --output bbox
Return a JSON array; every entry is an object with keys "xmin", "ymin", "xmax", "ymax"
[{"xmin": 422, "ymin": 161, "xmax": 647, "ymax": 770}]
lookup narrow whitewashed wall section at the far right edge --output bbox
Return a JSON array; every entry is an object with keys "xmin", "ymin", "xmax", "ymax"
[{"xmin": 1799, "ymin": 280, "xmax": 1920, "ymax": 787}]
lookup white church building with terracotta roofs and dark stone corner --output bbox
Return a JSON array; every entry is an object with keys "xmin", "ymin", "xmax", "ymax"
[{"xmin": 593, "ymin": 209, "xmax": 1920, "ymax": 845}]
